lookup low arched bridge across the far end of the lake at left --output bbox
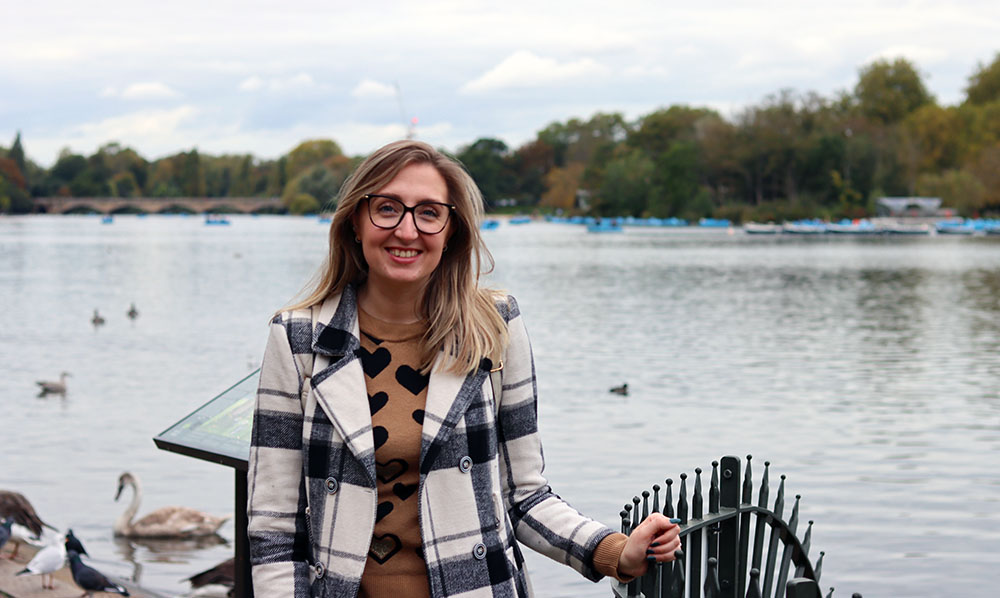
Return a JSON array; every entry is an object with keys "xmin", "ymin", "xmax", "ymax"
[{"xmin": 34, "ymin": 197, "xmax": 285, "ymax": 214}]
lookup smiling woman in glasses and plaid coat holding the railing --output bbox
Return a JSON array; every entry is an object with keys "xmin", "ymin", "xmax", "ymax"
[{"xmin": 249, "ymin": 141, "xmax": 680, "ymax": 598}]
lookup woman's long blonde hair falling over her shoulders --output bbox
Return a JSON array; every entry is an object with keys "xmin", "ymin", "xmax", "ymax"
[{"xmin": 285, "ymin": 140, "xmax": 508, "ymax": 374}]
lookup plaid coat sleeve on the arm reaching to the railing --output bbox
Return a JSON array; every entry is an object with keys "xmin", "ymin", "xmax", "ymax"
[{"xmin": 498, "ymin": 297, "xmax": 613, "ymax": 581}]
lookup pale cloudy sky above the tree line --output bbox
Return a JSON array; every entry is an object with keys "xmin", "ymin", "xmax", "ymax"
[{"xmin": 0, "ymin": 0, "xmax": 1000, "ymax": 167}]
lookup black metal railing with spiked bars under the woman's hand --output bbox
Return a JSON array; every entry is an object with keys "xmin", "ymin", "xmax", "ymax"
[{"xmin": 612, "ymin": 455, "xmax": 860, "ymax": 598}]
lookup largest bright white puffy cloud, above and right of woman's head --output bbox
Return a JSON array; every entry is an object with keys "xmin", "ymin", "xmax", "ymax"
[{"xmin": 459, "ymin": 50, "xmax": 610, "ymax": 94}]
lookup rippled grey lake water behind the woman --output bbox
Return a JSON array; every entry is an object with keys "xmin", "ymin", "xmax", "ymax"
[{"xmin": 0, "ymin": 217, "xmax": 1000, "ymax": 597}]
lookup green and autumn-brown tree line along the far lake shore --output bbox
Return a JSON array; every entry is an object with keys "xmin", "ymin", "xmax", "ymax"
[{"xmin": 0, "ymin": 53, "xmax": 1000, "ymax": 221}]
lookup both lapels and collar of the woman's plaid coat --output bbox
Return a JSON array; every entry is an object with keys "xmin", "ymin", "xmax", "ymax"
[{"xmin": 312, "ymin": 285, "xmax": 489, "ymax": 484}]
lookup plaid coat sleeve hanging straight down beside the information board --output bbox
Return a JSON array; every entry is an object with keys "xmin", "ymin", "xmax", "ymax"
[{"xmin": 247, "ymin": 314, "xmax": 311, "ymax": 598}]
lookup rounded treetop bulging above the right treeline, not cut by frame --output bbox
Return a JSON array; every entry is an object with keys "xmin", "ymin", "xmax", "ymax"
[{"xmin": 854, "ymin": 58, "xmax": 934, "ymax": 124}]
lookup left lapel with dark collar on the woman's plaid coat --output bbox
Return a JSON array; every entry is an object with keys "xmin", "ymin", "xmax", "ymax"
[{"xmin": 312, "ymin": 286, "xmax": 375, "ymax": 483}]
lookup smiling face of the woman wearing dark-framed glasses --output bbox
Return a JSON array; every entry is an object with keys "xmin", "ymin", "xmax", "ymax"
[{"xmin": 354, "ymin": 163, "xmax": 452, "ymax": 288}]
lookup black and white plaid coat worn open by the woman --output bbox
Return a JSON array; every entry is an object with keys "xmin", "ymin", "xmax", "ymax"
[{"xmin": 248, "ymin": 288, "xmax": 612, "ymax": 598}]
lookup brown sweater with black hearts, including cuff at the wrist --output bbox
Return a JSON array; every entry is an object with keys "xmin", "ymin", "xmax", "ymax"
[{"xmin": 358, "ymin": 309, "xmax": 626, "ymax": 598}]
